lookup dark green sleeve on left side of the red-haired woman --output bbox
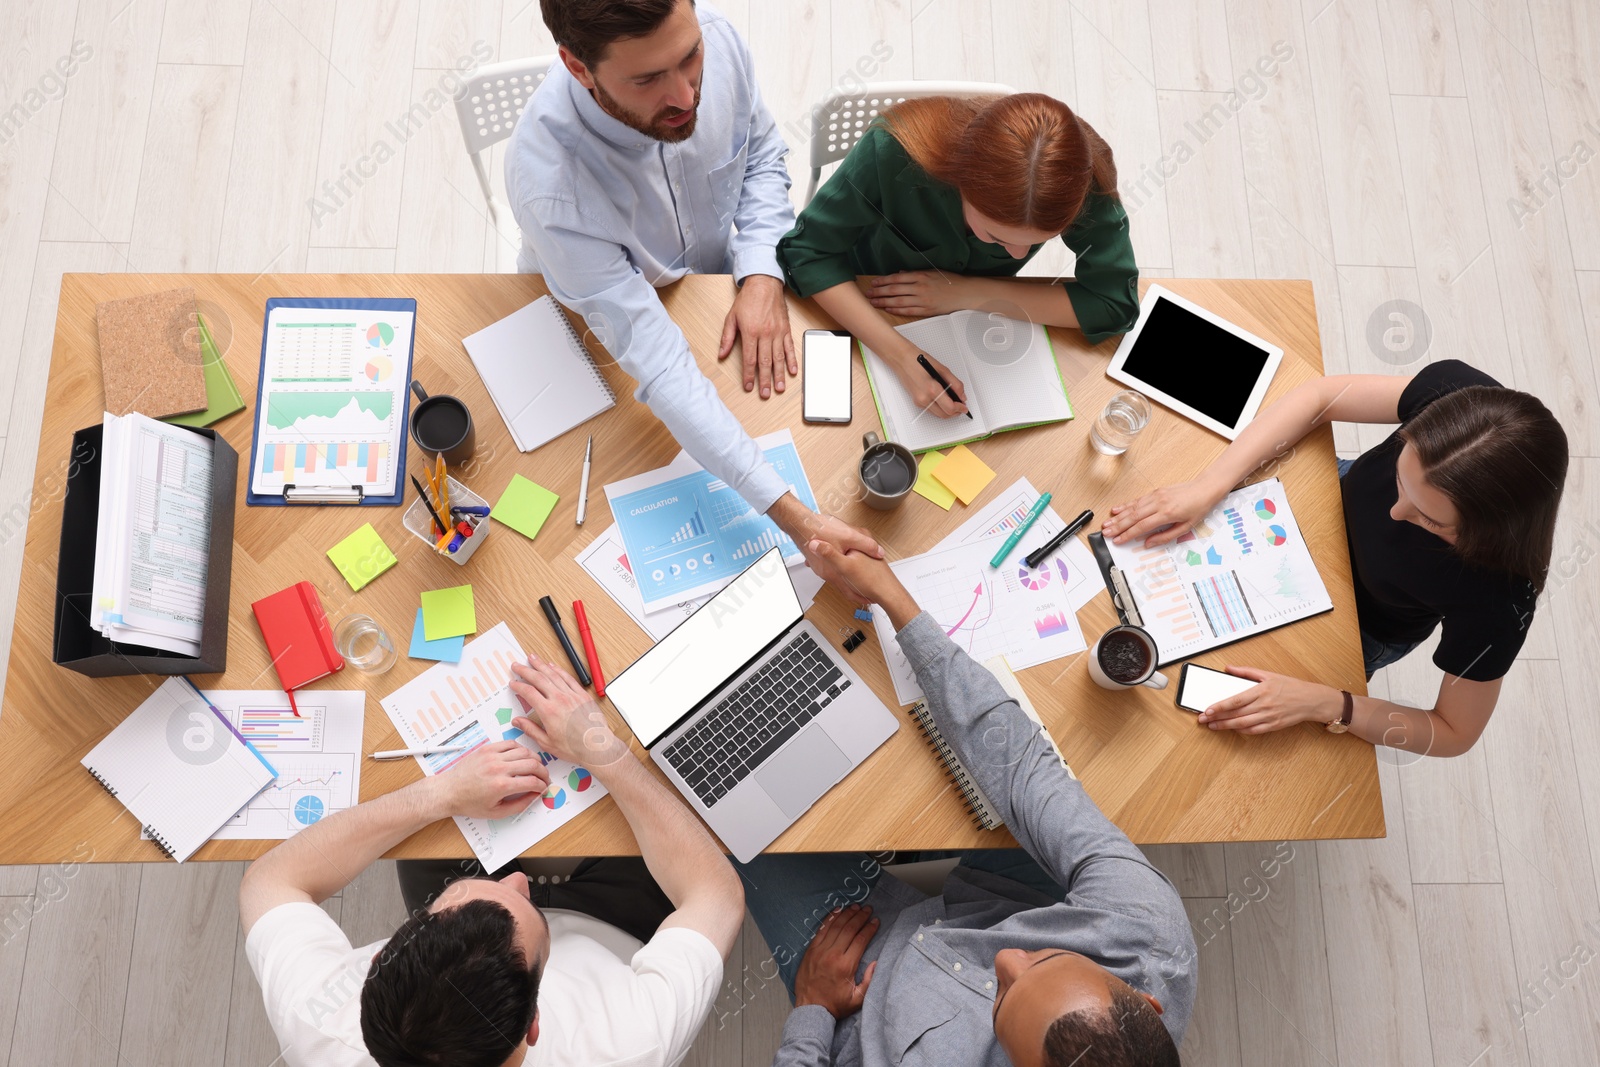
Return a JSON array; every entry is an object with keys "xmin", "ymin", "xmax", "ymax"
[{"xmin": 778, "ymin": 126, "xmax": 890, "ymax": 296}]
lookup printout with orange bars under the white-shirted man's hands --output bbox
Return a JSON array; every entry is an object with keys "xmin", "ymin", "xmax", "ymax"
[{"xmin": 381, "ymin": 622, "xmax": 606, "ymax": 870}]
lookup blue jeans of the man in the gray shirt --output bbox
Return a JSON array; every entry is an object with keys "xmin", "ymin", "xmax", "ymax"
[{"xmin": 734, "ymin": 848, "xmax": 1067, "ymax": 1003}]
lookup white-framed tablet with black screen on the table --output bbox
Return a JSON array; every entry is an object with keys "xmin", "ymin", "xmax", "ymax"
[{"xmin": 1106, "ymin": 285, "xmax": 1283, "ymax": 440}]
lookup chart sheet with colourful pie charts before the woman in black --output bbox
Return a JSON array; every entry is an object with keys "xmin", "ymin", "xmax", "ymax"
[{"xmin": 1106, "ymin": 478, "xmax": 1333, "ymax": 667}]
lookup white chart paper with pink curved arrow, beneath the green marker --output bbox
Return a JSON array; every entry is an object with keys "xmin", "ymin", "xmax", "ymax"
[{"xmin": 872, "ymin": 537, "xmax": 1088, "ymax": 704}]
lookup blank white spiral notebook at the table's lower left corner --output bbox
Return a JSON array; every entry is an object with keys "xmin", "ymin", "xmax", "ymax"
[{"xmin": 82, "ymin": 677, "xmax": 278, "ymax": 862}]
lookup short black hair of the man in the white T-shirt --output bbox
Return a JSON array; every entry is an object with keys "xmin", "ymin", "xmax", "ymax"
[{"xmin": 362, "ymin": 901, "xmax": 539, "ymax": 1067}]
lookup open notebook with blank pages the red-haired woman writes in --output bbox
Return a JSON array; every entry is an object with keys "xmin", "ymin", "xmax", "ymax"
[{"xmin": 861, "ymin": 312, "xmax": 1072, "ymax": 453}]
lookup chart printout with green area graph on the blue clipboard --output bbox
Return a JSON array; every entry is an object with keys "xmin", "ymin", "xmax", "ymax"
[{"xmin": 250, "ymin": 307, "xmax": 414, "ymax": 496}]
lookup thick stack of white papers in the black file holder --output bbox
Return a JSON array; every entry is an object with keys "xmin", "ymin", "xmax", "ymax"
[{"xmin": 90, "ymin": 413, "xmax": 216, "ymax": 656}]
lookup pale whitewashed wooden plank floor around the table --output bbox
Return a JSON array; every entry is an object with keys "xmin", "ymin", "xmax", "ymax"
[{"xmin": 0, "ymin": 0, "xmax": 1600, "ymax": 1067}]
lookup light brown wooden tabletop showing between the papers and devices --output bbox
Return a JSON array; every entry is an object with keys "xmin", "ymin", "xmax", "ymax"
[{"xmin": 0, "ymin": 274, "xmax": 1384, "ymax": 864}]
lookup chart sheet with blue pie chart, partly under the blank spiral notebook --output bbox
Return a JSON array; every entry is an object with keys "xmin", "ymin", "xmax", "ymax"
[{"xmin": 206, "ymin": 689, "xmax": 366, "ymax": 840}]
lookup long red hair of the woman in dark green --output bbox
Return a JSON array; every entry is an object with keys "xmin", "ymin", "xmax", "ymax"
[{"xmin": 880, "ymin": 93, "xmax": 1117, "ymax": 234}]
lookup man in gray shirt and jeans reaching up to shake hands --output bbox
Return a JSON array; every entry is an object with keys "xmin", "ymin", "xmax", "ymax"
[{"xmin": 741, "ymin": 542, "xmax": 1197, "ymax": 1067}]
